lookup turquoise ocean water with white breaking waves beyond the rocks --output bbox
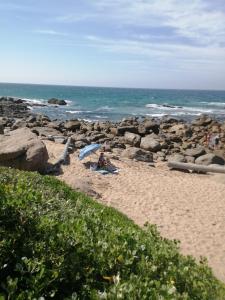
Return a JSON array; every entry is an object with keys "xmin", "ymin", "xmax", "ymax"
[{"xmin": 0, "ymin": 83, "xmax": 225, "ymax": 121}]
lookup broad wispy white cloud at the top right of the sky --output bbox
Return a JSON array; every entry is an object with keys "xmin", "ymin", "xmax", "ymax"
[{"xmin": 87, "ymin": 0, "xmax": 225, "ymax": 44}]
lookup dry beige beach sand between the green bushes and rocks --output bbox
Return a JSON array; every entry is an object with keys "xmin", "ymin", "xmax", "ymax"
[{"xmin": 46, "ymin": 142, "xmax": 225, "ymax": 281}]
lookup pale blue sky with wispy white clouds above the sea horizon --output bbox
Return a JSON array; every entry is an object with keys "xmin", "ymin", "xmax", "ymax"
[{"xmin": 0, "ymin": 0, "xmax": 225, "ymax": 90}]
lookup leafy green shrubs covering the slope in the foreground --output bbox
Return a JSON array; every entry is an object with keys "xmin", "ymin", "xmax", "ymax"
[{"xmin": 0, "ymin": 168, "xmax": 225, "ymax": 300}]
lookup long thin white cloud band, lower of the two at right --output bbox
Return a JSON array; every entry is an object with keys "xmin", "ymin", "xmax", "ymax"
[{"xmin": 86, "ymin": 36, "xmax": 225, "ymax": 68}]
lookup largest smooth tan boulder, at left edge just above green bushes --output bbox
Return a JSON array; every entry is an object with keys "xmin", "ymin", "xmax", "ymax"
[{"xmin": 0, "ymin": 128, "xmax": 48, "ymax": 172}]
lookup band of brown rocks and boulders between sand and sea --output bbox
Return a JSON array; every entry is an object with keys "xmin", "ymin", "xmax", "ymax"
[{"xmin": 0, "ymin": 97, "xmax": 225, "ymax": 171}]
